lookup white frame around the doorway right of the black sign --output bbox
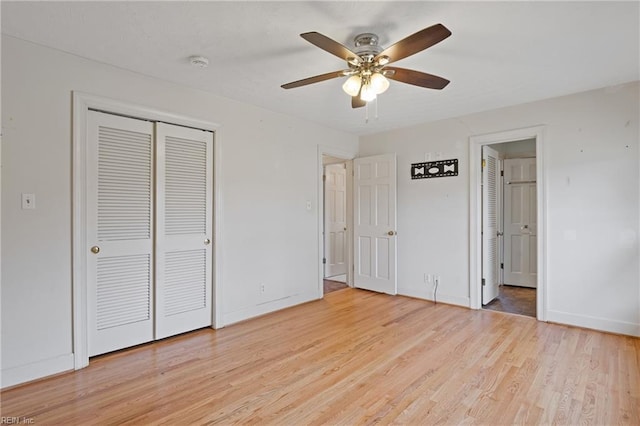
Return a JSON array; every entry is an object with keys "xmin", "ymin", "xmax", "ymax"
[{"xmin": 469, "ymin": 126, "xmax": 548, "ymax": 321}]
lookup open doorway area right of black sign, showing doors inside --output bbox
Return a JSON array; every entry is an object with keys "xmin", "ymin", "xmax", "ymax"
[{"xmin": 482, "ymin": 138, "xmax": 538, "ymax": 317}]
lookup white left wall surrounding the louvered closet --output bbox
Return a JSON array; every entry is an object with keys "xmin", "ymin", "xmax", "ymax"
[{"xmin": 1, "ymin": 36, "xmax": 358, "ymax": 386}]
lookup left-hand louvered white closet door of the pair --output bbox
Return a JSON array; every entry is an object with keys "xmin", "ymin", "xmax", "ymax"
[{"xmin": 85, "ymin": 111, "xmax": 154, "ymax": 356}]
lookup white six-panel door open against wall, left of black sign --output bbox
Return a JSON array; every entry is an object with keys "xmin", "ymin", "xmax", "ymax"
[{"xmin": 354, "ymin": 154, "xmax": 397, "ymax": 294}]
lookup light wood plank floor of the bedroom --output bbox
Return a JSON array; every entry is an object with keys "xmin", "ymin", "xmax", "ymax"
[{"xmin": 1, "ymin": 289, "xmax": 640, "ymax": 425}]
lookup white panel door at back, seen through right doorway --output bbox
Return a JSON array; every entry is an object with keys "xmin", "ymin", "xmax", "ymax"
[{"xmin": 504, "ymin": 158, "xmax": 537, "ymax": 288}]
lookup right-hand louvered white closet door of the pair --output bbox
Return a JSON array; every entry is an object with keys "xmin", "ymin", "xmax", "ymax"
[{"xmin": 156, "ymin": 123, "xmax": 213, "ymax": 339}]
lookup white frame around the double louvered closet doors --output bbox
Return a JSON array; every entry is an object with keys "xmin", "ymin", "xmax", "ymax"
[{"xmin": 71, "ymin": 91, "xmax": 224, "ymax": 370}]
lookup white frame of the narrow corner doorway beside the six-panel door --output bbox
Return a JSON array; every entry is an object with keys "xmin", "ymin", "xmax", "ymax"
[{"xmin": 317, "ymin": 145, "xmax": 357, "ymax": 299}]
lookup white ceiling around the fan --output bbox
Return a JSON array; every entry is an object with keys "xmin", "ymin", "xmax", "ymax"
[{"xmin": 2, "ymin": 1, "xmax": 640, "ymax": 135}]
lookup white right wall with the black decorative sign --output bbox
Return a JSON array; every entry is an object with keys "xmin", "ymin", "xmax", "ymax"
[{"xmin": 360, "ymin": 82, "xmax": 640, "ymax": 336}]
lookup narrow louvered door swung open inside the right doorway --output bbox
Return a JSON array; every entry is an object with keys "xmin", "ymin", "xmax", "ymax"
[{"xmin": 482, "ymin": 146, "xmax": 500, "ymax": 305}]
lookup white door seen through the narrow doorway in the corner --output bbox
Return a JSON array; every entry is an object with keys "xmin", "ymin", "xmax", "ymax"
[{"xmin": 324, "ymin": 163, "xmax": 347, "ymax": 278}]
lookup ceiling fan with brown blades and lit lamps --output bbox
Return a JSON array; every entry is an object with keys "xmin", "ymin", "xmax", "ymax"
[{"xmin": 281, "ymin": 24, "xmax": 451, "ymax": 108}]
